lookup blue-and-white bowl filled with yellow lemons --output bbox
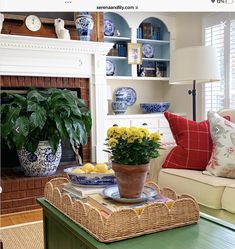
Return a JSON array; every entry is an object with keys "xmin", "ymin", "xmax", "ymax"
[{"xmin": 64, "ymin": 163, "xmax": 116, "ymax": 187}]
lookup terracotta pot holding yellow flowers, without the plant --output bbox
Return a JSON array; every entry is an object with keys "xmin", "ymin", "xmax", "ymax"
[{"xmin": 112, "ymin": 162, "xmax": 149, "ymax": 198}]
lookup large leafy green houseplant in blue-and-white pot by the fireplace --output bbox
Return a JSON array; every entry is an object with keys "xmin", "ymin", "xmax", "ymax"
[{"xmin": 1, "ymin": 88, "xmax": 92, "ymax": 176}]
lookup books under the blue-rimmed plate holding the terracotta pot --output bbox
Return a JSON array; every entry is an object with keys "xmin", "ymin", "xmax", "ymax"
[{"xmin": 87, "ymin": 194, "xmax": 173, "ymax": 215}]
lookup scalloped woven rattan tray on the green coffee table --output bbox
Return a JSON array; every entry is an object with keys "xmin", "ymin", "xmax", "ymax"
[{"xmin": 44, "ymin": 178, "xmax": 199, "ymax": 242}]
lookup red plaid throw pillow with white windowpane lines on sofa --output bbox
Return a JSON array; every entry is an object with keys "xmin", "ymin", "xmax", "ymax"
[{"xmin": 162, "ymin": 112, "xmax": 213, "ymax": 170}]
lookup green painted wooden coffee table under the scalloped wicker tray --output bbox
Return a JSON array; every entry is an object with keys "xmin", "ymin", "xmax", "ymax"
[{"xmin": 37, "ymin": 198, "xmax": 235, "ymax": 249}]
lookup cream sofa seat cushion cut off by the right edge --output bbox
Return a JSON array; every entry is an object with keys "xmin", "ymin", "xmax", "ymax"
[{"xmin": 222, "ymin": 183, "xmax": 235, "ymax": 214}]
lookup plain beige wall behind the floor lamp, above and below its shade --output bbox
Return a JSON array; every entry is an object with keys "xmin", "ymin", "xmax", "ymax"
[{"xmin": 163, "ymin": 12, "xmax": 206, "ymax": 120}]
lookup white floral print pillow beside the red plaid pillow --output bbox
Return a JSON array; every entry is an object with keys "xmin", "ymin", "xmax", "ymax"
[{"xmin": 206, "ymin": 112, "xmax": 235, "ymax": 178}]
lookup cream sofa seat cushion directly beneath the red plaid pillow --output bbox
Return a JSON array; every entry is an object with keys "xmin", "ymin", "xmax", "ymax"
[{"xmin": 158, "ymin": 169, "xmax": 234, "ymax": 209}]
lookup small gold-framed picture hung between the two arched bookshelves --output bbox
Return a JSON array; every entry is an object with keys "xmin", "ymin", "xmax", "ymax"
[{"xmin": 127, "ymin": 43, "xmax": 142, "ymax": 64}]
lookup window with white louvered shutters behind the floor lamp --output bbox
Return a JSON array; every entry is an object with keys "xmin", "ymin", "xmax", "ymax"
[{"xmin": 203, "ymin": 13, "xmax": 235, "ymax": 116}]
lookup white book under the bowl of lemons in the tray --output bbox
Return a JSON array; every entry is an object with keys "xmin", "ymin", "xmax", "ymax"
[{"xmin": 62, "ymin": 183, "xmax": 104, "ymax": 198}]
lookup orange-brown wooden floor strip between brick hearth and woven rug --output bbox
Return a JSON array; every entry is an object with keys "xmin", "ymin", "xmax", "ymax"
[{"xmin": 0, "ymin": 209, "xmax": 42, "ymax": 227}]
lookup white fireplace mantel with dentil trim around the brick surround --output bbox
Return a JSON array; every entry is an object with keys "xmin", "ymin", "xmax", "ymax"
[{"xmin": 0, "ymin": 34, "xmax": 113, "ymax": 162}]
